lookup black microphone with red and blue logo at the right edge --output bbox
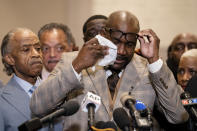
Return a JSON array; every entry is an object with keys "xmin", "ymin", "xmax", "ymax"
[{"xmin": 180, "ymin": 92, "xmax": 197, "ymax": 121}]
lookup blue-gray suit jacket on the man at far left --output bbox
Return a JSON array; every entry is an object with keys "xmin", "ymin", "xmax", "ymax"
[{"xmin": 0, "ymin": 77, "xmax": 31, "ymax": 131}]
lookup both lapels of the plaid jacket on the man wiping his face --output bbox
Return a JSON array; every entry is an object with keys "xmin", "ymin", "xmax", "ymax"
[{"xmin": 85, "ymin": 55, "xmax": 147, "ymax": 116}]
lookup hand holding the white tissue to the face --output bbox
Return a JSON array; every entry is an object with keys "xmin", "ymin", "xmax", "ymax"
[{"xmin": 72, "ymin": 38, "xmax": 108, "ymax": 73}]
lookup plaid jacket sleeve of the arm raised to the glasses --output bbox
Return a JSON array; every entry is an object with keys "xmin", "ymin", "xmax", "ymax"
[{"xmin": 150, "ymin": 63, "xmax": 189, "ymax": 124}]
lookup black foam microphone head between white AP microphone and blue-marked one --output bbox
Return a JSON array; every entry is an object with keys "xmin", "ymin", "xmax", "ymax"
[{"xmin": 113, "ymin": 108, "xmax": 130, "ymax": 129}]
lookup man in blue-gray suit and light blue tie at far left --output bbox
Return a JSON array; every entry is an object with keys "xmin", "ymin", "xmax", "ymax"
[{"xmin": 0, "ymin": 28, "xmax": 42, "ymax": 131}]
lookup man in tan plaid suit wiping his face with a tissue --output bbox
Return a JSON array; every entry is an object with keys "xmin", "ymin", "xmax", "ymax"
[{"xmin": 30, "ymin": 11, "xmax": 188, "ymax": 131}]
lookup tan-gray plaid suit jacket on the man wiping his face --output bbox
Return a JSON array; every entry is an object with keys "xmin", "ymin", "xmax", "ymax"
[{"xmin": 30, "ymin": 52, "xmax": 188, "ymax": 131}]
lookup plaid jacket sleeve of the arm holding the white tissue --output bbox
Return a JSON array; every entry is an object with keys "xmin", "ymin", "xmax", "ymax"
[{"xmin": 30, "ymin": 53, "xmax": 81, "ymax": 116}]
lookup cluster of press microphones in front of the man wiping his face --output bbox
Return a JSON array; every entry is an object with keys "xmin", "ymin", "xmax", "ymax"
[{"xmin": 18, "ymin": 92, "xmax": 197, "ymax": 131}]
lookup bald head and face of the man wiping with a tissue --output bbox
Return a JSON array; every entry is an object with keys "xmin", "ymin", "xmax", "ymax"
[{"xmin": 104, "ymin": 11, "xmax": 140, "ymax": 71}]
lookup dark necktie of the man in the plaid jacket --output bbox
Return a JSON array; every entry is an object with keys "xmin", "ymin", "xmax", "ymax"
[{"xmin": 107, "ymin": 70, "xmax": 120, "ymax": 99}]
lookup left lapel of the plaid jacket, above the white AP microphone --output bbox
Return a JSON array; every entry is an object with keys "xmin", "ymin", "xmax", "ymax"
[{"xmin": 84, "ymin": 65, "xmax": 110, "ymax": 114}]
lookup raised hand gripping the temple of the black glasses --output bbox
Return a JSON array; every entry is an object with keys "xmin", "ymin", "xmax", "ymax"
[{"xmin": 138, "ymin": 29, "xmax": 160, "ymax": 64}]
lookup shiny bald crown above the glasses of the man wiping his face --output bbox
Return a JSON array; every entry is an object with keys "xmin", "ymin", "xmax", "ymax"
[{"xmin": 107, "ymin": 11, "xmax": 140, "ymax": 33}]
